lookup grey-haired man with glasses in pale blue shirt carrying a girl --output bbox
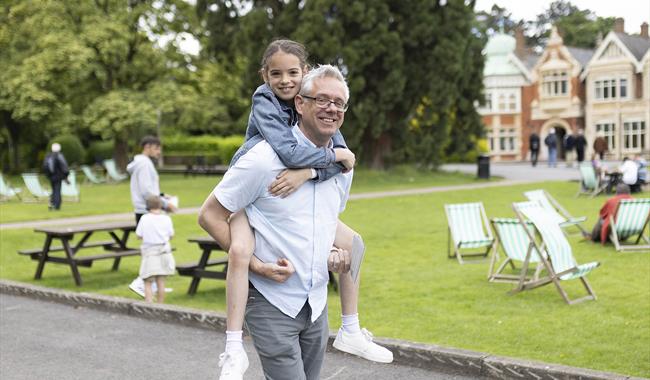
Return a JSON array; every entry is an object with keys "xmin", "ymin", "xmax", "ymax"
[{"xmin": 199, "ymin": 65, "xmax": 352, "ymax": 379}]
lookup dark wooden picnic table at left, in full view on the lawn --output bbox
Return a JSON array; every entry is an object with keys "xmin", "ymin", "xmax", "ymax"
[{"xmin": 18, "ymin": 222, "xmax": 140, "ymax": 286}]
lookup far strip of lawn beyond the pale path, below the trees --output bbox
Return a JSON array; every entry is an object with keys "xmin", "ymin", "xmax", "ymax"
[{"xmin": 0, "ymin": 166, "xmax": 476, "ymax": 223}]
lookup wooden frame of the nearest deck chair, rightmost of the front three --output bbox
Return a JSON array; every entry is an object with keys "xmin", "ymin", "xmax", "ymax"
[{"xmin": 512, "ymin": 202, "xmax": 600, "ymax": 305}]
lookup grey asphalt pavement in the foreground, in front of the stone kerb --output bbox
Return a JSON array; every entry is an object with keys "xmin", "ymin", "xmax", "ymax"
[{"xmin": 0, "ymin": 294, "xmax": 470, "ymax": 380}]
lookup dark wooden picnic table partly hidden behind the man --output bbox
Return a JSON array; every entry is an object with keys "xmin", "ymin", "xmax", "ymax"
[{"xmin": 176, "ymin": 236, "xmax": 228, "ymax": 295}]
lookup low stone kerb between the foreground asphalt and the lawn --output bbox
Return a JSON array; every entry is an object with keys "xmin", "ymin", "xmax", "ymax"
[{"xmin": 0, "ymin": 280, "xmax": 641, "ymax": 380}]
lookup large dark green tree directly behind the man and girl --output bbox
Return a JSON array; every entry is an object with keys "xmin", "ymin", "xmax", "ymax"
[{"xmin": 198, "ymin": 0, "xmax": 482, "ymax": 168}]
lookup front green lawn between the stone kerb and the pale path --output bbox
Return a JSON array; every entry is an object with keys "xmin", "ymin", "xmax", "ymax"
[{"xmin": 0, "ymin": 182, "xmax": 650, "ymax": 377}]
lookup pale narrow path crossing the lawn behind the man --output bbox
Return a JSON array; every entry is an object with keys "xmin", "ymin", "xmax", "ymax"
[{"xmin": 0, "ymin": 162, "xmax": 580, "ymax": 230}]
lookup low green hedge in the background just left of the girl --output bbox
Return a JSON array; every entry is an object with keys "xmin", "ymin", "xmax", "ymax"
[{"xmin": 163, "ymin": 135, "xmax": 244, "ymax": 165}]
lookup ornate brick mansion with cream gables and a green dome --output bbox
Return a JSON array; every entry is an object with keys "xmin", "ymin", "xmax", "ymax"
[{"xmin": 478, "ymin": 18, "xmax": 650, "ymax": 161}]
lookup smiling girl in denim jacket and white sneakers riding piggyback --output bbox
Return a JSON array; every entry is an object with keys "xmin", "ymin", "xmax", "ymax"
[{"xmin": 213, "ymin": 40, "xmax": 393, "ymax": 380}]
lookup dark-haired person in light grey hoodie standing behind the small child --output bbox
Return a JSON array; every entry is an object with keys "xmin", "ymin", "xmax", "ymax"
[{"xmin": 126, "ymin": 136, "xmax": 176, "ymax": 297}]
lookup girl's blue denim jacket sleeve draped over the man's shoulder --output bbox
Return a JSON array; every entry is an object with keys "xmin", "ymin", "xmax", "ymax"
[{"xmin": 251, "ymin": 93, "xmax": 336, "ymax": 169}]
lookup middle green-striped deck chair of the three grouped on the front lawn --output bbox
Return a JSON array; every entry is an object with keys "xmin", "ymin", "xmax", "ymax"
[{"xmin": 488, "ymin": 218, "xmax": 543, "ymax": 283}]
